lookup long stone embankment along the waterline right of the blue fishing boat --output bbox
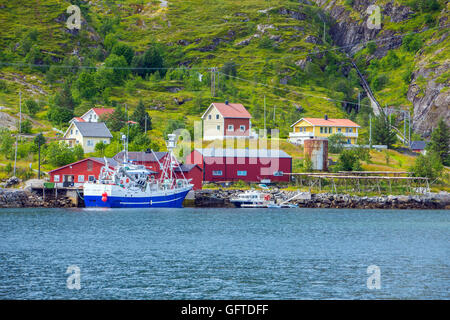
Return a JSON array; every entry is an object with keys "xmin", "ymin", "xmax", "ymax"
[{"xmin": 195, "ymin": 190, "xmax": 450, "ymax": 209}]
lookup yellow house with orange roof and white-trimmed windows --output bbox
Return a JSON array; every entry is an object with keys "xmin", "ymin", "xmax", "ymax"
[{"xmin": 289, "ymin": 116, "xmax": 360, "ymax": 144}]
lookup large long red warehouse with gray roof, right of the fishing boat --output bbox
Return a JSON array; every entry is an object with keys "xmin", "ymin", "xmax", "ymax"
[{"xmin": 186, "ymin": 148, "xmax": 292, "ymax": 183}]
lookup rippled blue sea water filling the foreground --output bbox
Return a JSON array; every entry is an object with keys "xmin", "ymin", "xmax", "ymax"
[{"xmin": 0, "ymin": 209, "xmax": 450, "ymax": 299}]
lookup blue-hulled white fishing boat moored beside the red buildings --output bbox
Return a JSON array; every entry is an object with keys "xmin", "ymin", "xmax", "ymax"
[{"xmin": 83, "ymin": 134, "xmax": 193, "ymax": 208}]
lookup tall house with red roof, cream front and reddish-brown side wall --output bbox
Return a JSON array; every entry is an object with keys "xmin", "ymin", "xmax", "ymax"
[{"xmin": 202, "ymin": 101, "xmax": 255, "ymax": 140}]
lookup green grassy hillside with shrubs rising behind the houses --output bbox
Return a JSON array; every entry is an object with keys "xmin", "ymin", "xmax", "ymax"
[{"xmin": 0, "ymin": 0, "xmax": 449, "ymax": 181}]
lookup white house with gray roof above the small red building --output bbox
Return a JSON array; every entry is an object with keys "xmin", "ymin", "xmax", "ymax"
[{"xmin": 64, "ymin": 121, "xmax": 112, "ymax": 153}]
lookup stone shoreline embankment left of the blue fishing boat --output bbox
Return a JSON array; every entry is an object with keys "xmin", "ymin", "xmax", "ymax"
[{"xmin": 0, "ymin": 189, "xmax": 74, "ymax": 208}]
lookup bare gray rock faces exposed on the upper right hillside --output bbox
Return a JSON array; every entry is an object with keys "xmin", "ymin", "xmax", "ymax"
[{"xmin": 314, "ymin": 0, "xmax": 450, "ymax": 138}]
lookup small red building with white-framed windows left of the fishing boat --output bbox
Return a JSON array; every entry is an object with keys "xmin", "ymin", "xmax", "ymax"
[{"xmin": 49, "ymin": 158, "xmax": 117, "ymax": 187}]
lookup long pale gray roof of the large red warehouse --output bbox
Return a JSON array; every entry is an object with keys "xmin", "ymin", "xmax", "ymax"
[{"xmin": 195, "ymin": 148, "xmax": 292, "ymax": 159}]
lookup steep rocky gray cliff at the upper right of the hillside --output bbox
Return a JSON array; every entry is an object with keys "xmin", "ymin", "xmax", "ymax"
[{"xmin": 314, "ymin": 0, "xmax": 450, "ymax": 138}]
